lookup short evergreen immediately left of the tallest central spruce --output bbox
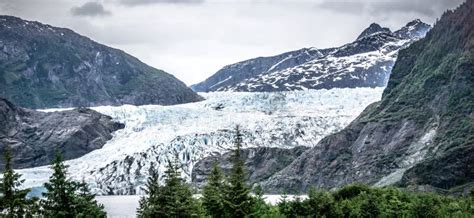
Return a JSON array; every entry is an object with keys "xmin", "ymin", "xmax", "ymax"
[{"xmin": 202, "ymin": 163, "xmax": 225, "ymax": 217}]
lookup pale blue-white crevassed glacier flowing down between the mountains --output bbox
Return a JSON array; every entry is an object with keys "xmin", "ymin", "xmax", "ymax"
[{"xmin": 19, "ymin": 88, "xmax": 383, "ymax": 194}]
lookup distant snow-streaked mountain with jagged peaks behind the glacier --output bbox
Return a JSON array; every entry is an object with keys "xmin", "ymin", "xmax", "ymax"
[{"xmin": 191, "ymin": 20, "xmax": 430, "ymax": 92}]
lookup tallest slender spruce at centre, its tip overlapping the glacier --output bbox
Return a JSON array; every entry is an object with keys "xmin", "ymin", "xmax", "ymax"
[{"xmin": 224, "ymin": 126, "xmax": 253, "ymax": 217}]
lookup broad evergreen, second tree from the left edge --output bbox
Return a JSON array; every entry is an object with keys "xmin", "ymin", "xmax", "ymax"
[{"xmin": 41, "ymin": 152, "xmax": 106, "ymax": 217}]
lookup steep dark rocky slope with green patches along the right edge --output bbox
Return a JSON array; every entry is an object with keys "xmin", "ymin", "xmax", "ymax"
[{"xmin": 263, "ymin": 0, "xmax": 474, "ymax": 192}]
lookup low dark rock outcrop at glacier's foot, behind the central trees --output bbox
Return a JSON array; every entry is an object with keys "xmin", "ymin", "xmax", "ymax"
[{"xmin": 191, "ymin": 146, "xmax": 309, "ymax": 187}]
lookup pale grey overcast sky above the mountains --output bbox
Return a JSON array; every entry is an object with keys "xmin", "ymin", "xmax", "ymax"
[{"xmin": 0, "ymin": 0, "xmax": 463, "ymax": 85}]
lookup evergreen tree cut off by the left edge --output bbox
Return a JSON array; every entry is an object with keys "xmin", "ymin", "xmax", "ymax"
[{"xmin": 0, "ymin": 147, "xmax": 35, "ymax": 217}]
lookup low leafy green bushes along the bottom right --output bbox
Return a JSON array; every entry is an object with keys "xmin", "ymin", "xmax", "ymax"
[{"xmin": 270, "ymin": 184, "xmax": 474, "ymax": 217}]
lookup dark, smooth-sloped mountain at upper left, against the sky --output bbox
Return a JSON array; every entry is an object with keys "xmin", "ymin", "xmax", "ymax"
[{"xmin": 0, "ymin": 16, "xmax": 202, "ymax": 108}]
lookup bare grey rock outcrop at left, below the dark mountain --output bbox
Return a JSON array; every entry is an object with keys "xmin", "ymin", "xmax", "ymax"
[{"xmin": 0, "ymin": 98, "xmax": 124, "ymax": 169}]
